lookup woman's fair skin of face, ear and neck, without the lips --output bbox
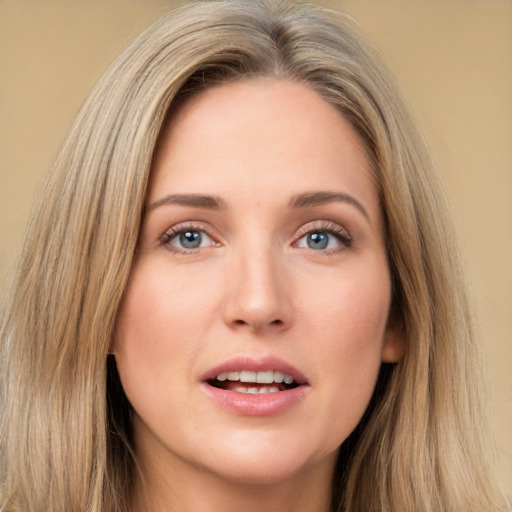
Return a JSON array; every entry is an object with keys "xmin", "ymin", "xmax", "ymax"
[{"xmin": 112, "ymin": 79, "xmax": 404, "ymax": 512}]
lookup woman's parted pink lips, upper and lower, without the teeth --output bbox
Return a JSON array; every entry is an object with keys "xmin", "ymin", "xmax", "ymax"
[{"xmin": 201, "ymin": 357, "xmax": 309, "ymax": 416}]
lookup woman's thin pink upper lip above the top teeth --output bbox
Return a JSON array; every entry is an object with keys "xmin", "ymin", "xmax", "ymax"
[{"xmin": 201, "ymin": 356, "xmax": 308, "ymax": 385}]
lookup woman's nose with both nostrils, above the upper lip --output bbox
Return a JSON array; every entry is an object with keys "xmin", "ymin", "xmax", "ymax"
[{"xmin": 223, "ymin": 242, "xmax": 292, "ymax": 334}]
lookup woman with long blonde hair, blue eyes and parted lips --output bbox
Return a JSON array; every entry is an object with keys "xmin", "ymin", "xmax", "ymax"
[{"xmin": 1, "ymin": 1, "xmax": 505, "ymax": 512}]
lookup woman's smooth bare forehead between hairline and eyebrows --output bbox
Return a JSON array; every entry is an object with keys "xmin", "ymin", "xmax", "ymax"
[{"xmin": 148, "ymin": 78, "xmax": 378, "ymax": 220}]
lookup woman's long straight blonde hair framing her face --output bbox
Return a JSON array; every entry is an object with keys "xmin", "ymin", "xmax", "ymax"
[{"xmin": 0, "ymin": 0, "xmax": 505, "ymax": 512}]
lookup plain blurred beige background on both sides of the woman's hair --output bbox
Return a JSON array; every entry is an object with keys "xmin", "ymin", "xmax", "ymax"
[{"xmin": 0, "ymin": 0, "xmax": 512, "ymax": 495}]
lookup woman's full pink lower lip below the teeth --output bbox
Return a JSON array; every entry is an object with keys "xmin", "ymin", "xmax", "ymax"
[{"xmin": 203, "ymin": 382, "xmax": 309, "ymax": 416}]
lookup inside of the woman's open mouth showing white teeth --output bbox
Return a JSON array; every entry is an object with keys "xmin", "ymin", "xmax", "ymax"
[{"xmin": 207, "ymin": 370, "xmax": 300, "ymax": 395}]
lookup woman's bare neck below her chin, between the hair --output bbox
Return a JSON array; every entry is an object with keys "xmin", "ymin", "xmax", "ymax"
[{"xmin": 130, "ymin": 448, "xmax": 336, "ymax": 512}]
